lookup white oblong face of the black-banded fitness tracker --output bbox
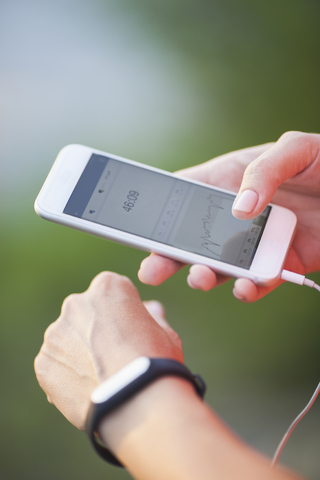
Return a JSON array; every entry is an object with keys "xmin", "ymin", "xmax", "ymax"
[{"xmin": 91, "ymin": 357, "xmax": 151, "ymax": 403}]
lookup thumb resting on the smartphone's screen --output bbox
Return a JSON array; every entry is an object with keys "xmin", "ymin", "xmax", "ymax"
[{"xmin": 232, "ymin": 132, "xmax": 320, "ymax": 219}]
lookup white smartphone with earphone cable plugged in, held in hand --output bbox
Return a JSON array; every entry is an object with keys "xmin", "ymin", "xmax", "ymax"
[{"xmin": 35, "ymin": 145, "xmax": 296, "ymax": 285}]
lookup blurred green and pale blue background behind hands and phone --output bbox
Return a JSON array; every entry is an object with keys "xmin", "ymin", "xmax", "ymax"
[{"xmin": 0, "ymin": 0, "xmax": 320, "ymax": 480}]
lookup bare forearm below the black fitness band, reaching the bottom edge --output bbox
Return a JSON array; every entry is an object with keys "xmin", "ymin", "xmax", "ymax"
[{"xmin": 100, "ymin": 378, "xmax": 297, "ymax": 480}]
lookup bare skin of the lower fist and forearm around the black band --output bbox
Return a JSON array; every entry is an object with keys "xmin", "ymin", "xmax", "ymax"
[{"xmin": 35, "ymin": 272, "xmax": 298, "ymax": 480}]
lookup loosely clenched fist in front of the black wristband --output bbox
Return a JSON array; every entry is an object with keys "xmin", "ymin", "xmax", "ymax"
[{"xmin": 35, "ymin": 272, "xmax": 183, "ymax": 430}]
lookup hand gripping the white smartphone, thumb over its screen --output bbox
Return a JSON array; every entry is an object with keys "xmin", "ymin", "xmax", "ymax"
[{"xmin": 138, "ymin": 132, "xmax": 320, "ymax": 302}]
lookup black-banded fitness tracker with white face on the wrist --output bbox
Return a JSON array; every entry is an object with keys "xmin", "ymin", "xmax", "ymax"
[{"xmin": 86, "ymin": 357, "xmax": 206, "ymax": 467}]
